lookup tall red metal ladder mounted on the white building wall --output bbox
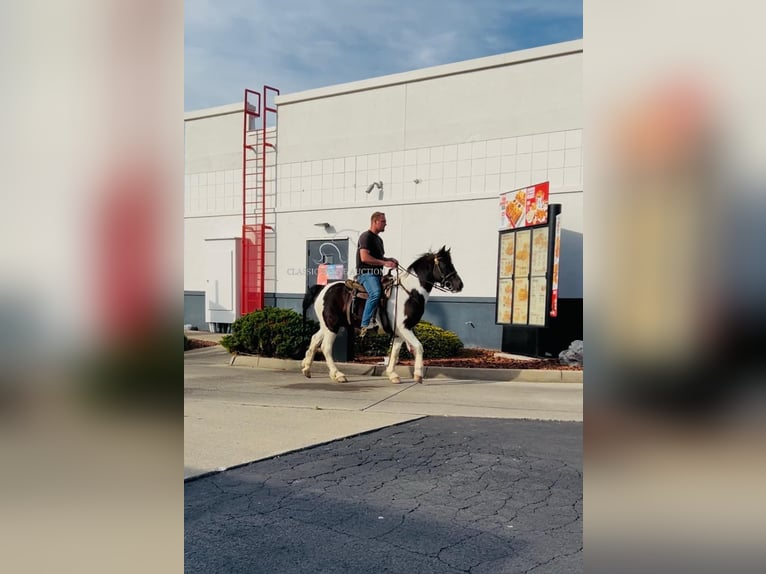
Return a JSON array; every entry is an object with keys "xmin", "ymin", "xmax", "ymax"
[{"xmin": 240, "ymin": 85, "xmax": 279, "ymax": 315}]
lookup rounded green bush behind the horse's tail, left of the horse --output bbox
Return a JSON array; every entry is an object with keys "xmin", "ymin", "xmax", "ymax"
[{"xmin": 221, "ymin": 307, "xmax": 319, "ymax": 359}]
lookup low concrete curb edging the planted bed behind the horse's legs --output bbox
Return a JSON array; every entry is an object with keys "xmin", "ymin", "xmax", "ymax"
[{"xmin": 229, "ymin": 354, "xmax": 583, "ymax": 384}]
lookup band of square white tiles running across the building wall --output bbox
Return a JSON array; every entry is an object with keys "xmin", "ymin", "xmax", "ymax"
[{"xmin": 184, "ymin": 129, "xmax": 583, "ymax": 216}]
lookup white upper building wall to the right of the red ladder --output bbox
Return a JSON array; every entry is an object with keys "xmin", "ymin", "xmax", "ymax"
[{"xmin": 276, "ymin": 42, "xmax": 583, "ymax": 298}]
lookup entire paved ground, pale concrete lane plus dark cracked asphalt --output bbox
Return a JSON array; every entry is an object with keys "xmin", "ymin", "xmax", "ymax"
[{"xmin": 184, "ymin": 351, "xmax": 583, "ymax": 574}]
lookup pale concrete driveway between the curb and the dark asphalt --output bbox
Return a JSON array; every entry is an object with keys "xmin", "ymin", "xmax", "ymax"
[{"xmin": 184, "ymin": 346, "xmax": 582, "ymax": 479}]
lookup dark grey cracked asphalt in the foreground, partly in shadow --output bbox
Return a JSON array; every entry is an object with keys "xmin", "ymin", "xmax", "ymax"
[{"xmin": 184, "ymin": 416, "xmax": 583, "ymax": 574}]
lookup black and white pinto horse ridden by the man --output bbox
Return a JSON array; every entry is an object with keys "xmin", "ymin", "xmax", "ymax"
[{"xmin": 301, "ymin": 247, "xmax": 463, "ymax": 383}]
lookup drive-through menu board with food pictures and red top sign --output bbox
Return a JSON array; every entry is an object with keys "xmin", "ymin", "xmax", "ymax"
[{"xmin": 495, "ymin": 182, "xmax": 561, "ymax": 327}]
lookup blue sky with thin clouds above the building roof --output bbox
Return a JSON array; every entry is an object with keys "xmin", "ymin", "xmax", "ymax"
[{"xmin": 184, "ymin": 0, "xmax": 582, "ymax": 111}]
